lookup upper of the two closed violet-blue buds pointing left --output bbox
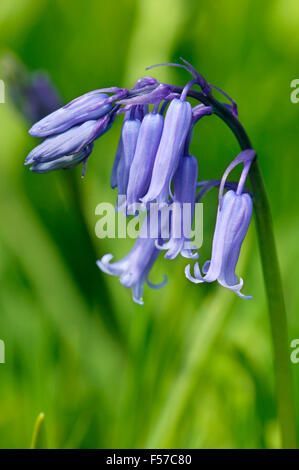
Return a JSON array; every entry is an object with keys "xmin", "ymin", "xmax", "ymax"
[{"xmin": 29, "ymin": 93, "xmax": 112, "ymax": 137}]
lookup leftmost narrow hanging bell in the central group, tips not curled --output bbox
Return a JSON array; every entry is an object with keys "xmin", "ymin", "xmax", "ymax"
[{"xmin": 117, "ymin": 119, "xmax": 141, "ymax": 195}]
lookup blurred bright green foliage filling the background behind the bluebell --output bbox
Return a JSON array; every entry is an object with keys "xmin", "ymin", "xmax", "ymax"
[{"xmin": 0, "ymin": 0, "xmax": 299, "ymax": 448}]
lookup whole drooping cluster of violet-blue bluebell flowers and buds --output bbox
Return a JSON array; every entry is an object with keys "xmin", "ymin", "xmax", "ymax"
[{"xmin": 25, "ymin": 60, "xmax": 255, "ymax": 304}]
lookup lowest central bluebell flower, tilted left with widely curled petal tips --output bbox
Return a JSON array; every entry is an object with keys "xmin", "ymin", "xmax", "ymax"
[{"xmin": 97, "ymin": 234, "xmax": 167, "ymax": 305}]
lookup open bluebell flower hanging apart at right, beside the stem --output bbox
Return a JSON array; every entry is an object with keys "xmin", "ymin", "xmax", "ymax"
[{"xmin": 185, "ymin": 191, "xmax": 252, "ymax": 299}]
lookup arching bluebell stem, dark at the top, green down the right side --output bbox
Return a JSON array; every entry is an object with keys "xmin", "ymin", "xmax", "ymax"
[{"xmin": 175, "ymin": 87, "xmax": 297, "ymax": 449}]
